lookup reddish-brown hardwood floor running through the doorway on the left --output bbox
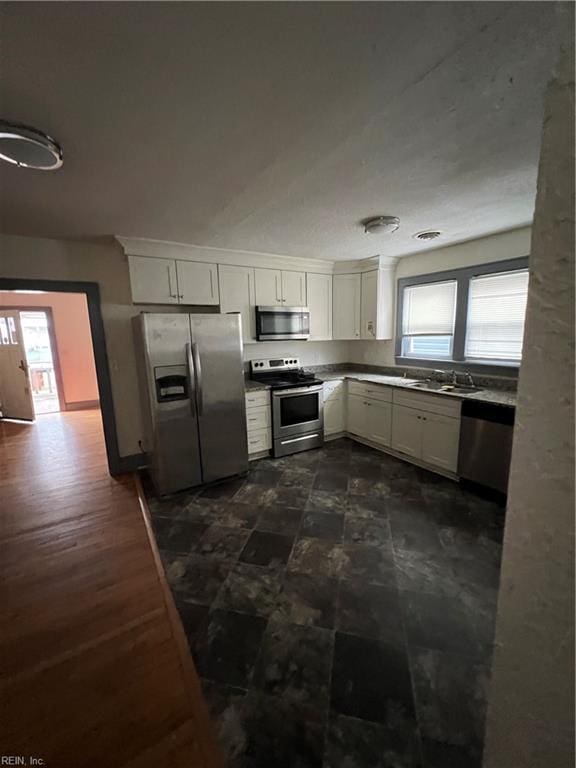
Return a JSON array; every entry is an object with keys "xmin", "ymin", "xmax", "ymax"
[{"xmin": 0, "ymin": 411, "xmax": 222, "ymax": 768}]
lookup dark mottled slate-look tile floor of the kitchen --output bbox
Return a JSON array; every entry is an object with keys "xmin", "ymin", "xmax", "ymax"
[{"xmin": 144, "ymin": 439, "xmax": 504, "ymax": 768}]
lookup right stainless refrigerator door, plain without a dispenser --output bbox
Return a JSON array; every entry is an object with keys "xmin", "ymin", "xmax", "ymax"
[{"xmin": 190, "ymin": 315, "xmax": 248, "ymax": 483}]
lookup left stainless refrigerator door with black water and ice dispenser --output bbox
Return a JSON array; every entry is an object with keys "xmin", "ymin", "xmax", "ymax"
[{"xmin": 138, "ymin": 314, "xmax": 202, "ymax": 494}]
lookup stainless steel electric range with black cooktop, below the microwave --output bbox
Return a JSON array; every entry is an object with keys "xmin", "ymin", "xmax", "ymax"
[{"xmin": 250, "ymin": 357, "xmax": 324, "ymax": 457}]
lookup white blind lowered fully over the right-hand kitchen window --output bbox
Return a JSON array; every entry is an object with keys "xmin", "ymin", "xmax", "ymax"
[{"xmin": 465, "ymin": 269, "xmax": 528, "ymax": 362}]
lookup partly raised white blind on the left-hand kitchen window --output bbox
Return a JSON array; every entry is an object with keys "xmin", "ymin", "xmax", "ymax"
[{"xmin": 402, "ymin": 280, "xmax": 456, "ymax": 336}]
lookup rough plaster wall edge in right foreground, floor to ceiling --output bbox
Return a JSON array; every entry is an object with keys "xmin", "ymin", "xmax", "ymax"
[{"xmin": 484, "ymin": 44, "xmax": 574, "ymax": 768}]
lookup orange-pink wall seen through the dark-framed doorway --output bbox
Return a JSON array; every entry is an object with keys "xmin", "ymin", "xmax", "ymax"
[{"xmin": 0, "ymin": 292, "xmax": 98, "ymax": 405}]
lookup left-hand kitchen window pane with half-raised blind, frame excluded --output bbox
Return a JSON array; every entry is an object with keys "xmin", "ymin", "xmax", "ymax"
[{"xmin": 402, "ymin": 280, "xmax": 457, "ymax": 360}]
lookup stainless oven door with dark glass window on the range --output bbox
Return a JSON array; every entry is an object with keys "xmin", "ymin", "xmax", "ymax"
[{"xmin": 272, "ymin": 385, "xmax": 324, "ymax": 440}]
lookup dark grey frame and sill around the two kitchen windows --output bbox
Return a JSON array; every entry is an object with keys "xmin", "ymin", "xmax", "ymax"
[{"xmin": 395, "ymin": 256, "xmax": 528, "ymax": 377}]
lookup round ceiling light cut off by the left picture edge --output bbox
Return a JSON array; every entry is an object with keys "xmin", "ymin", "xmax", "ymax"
[{"xmin": 0, "ymin": 120, "xmax": 63, "ymax": 171}]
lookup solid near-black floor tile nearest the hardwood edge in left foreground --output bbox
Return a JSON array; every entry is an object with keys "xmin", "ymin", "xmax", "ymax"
[{"xmin": 193, "ymin": 609, "xmax": 267, "ymax": 688}]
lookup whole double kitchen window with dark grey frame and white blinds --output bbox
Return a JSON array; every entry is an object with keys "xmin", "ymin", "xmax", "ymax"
[{"xmin": 396, "ymin": 258, "xmax": 528, "ymax": 367}]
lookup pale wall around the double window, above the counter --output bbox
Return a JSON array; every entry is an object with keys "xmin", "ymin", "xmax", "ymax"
[{"xmin": 350, "ymin": 227, "xmax": 531, "ymax": 365}]
